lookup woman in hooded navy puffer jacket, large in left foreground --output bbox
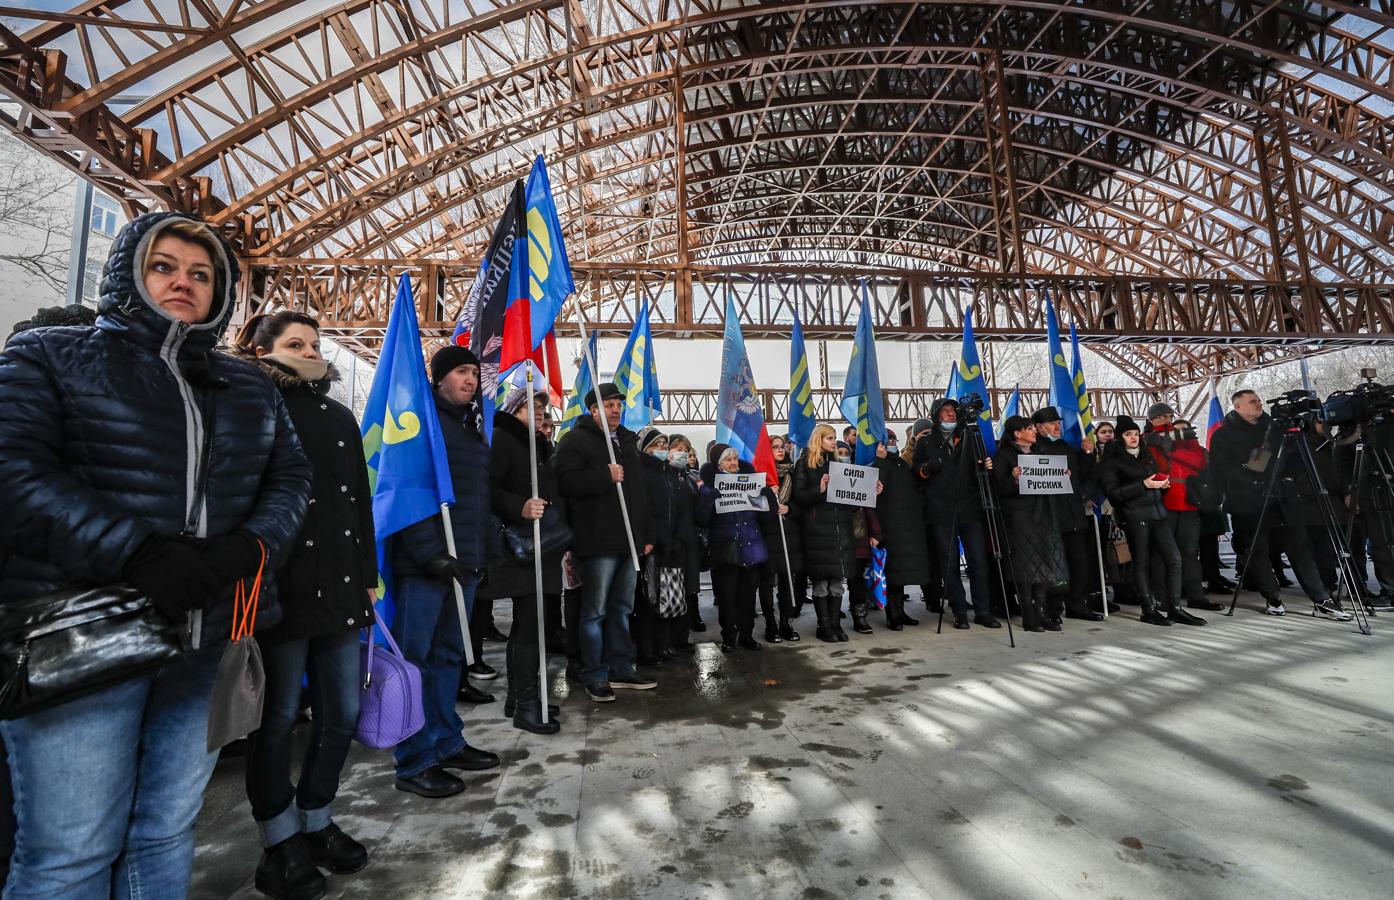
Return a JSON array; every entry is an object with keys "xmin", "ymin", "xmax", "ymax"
[{"xmin": 0, "ymin": 213, "xmax": 308, "ymax": 897}]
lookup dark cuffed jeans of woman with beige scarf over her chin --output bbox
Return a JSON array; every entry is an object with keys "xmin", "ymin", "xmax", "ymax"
[{"xmin": 247, "ymin": 630, "xmax": 362, "ymax": 847}]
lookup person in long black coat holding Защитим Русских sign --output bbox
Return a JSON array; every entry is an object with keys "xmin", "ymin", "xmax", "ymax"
[{"xmin": 993, "ymin": 415, "xmax": 1069, "ymax": 631}]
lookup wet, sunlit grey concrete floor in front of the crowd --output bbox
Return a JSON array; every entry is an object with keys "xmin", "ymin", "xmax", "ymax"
[{"xmin": 192, "ymin": 587, "xmax": 1394, "ymax": 900}]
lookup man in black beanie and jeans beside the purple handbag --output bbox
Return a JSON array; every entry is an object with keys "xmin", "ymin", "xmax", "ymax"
[{"xmin": 383, "ymin": 344, "xmax": 499, "ymax": 798}]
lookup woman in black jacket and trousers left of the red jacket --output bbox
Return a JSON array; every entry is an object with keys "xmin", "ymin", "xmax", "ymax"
[{"xmin": 1098, "ymin": 415, "xmax": 1204, "ymax": 626}]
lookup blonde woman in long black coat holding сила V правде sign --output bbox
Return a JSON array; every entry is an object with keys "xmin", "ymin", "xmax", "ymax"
[{"xmin": 792, "ymin": 425, "xmax": 857, "ymax": 644}]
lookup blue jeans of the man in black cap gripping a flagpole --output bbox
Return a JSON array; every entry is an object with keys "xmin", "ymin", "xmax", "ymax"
[{"xmin": 580, "ymin": 556, "xmax": 638, "ymax": 684}]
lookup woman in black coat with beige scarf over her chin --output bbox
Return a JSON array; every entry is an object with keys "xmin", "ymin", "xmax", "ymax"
[{"xmin": 237, "ymin": 311, "xmax": 378, "ymax": 897}]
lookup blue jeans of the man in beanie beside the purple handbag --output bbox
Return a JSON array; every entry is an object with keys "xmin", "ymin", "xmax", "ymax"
[{"xmin": 392, "ymin": 575, "xmax": 480, "ymax": 779}]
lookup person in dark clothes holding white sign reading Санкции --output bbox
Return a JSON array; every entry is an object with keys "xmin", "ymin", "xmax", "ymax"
[{"xmin": 697, "ymin": 444, "xmax": 789, "ymax": 653}]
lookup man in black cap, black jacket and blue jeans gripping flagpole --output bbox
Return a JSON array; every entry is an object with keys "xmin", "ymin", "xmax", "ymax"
[{"xmin": 552, "ymin": 382, "xmax": 658, "ymax": 704}]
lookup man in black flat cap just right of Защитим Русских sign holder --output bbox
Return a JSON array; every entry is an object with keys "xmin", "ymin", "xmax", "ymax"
[{"xmin": 1032, "ymin": 407, "xmax": 1104, "ymax": 621}]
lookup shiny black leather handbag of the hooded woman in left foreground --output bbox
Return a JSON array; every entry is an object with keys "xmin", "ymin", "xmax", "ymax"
[{"xmin": 0, "ymin": 585, "xmax": 191, "ymax": 719}]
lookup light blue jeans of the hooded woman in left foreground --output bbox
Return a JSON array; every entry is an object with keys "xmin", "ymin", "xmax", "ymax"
[{"xmin": 0, "ymin": 646, "xmax": 223, "ymax": 900}]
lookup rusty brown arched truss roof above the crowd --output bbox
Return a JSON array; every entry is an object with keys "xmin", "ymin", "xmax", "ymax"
[{"xmin": 8, "ymin": 0, "xmax": 1394, "ymax": 386}]
